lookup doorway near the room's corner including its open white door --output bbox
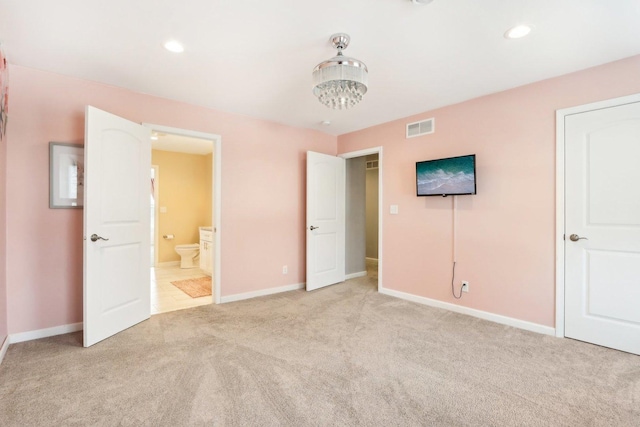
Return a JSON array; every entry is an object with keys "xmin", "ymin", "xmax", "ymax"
[{"xmin": 306, "ymin": 147, "xmax": 383, "ymax": 292}]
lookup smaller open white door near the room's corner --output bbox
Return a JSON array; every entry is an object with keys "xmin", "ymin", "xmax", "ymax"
[{"xmin": 307, "ymin": 151, "xmax": 345, "ymax": 291}]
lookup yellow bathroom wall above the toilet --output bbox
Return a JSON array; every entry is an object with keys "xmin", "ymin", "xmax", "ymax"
[{"xmin": 151, "ymin": 150, "xmax": 212, "ymax": 264}]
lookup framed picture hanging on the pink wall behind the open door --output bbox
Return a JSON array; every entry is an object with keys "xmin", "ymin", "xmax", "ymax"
[{"xmin": 49, "ymin": 142, "xmax": 84, "ymax": 209}]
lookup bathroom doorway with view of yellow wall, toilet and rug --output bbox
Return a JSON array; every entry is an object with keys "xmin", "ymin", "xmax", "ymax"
[{"xmin": 146, "ymin": 125, "xmax": 220, "ymax": 315}]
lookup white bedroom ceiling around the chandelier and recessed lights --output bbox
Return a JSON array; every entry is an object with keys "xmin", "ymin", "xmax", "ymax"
[{"xmin": 0, "ymin": 0, "xmax": 640, "ymax": 135}]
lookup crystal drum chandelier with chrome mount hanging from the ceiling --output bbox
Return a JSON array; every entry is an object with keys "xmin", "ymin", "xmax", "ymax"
[{"xmin": 313, "ymin": 33, "xmax": 369, "ymax": 110}]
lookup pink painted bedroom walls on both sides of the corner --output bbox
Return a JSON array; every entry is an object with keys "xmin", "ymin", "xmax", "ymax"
[{"xmin": 5, "ymin": 56, "xmax": 640, "ymax": 338}]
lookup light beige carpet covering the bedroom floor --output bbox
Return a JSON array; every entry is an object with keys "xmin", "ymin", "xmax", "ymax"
[{"xmin": 0, "ymin": 277, "xmax": 640, "ymax": 427}]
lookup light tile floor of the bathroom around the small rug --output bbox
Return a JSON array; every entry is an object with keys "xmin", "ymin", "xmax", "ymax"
[{"xmin": 151, "ymin": 266, "xmax": 213, "ymax": 314}]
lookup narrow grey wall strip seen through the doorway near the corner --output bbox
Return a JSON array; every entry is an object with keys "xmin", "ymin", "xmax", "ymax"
[{"xmin": 345, "ymin": 157, "xmax": 367, "ymax": 274}]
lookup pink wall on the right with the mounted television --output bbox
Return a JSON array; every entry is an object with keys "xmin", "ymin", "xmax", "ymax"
[{"xmin": 338, "ymin": 56, "xmax": 640, "ymax": 326}]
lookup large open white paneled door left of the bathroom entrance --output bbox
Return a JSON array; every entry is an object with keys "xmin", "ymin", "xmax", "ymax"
[{"xmin": 83, "ymin": 106, "xmax": 151, "ymax": 347}]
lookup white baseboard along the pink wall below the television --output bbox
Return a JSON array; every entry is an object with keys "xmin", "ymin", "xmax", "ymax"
[{"xmin": 379, "ymin": 288, "xmax": 556, "ymax": 336}]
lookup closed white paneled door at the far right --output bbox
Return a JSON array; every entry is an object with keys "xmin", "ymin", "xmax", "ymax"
[{"xmin": 565, "ymin": 102, "xmax": 640, "ymax": 354}]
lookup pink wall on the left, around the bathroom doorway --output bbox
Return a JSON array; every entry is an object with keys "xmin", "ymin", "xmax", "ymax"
[{"xmin": 7, "ymin": 65, "xmax": 337, "ymax": 333}]
